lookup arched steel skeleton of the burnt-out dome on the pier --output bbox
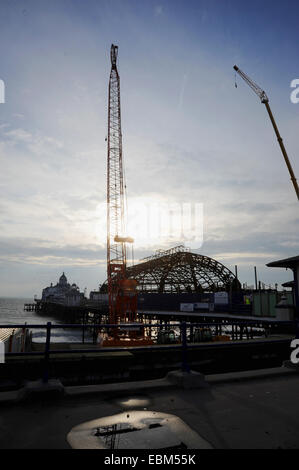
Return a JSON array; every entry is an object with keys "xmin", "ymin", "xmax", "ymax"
[{"xmin": 127, "ymin": 246, "xmax": 241, "ymax": 293}]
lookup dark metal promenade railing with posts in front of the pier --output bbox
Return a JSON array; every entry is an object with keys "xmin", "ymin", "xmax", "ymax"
[{"xmin": 0, "ymin": 320, "xmax": 299, "ymax": 383}]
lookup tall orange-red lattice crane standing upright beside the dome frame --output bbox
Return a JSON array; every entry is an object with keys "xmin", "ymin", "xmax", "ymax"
[{"xmin": 107, "ymin": 44, "xmax": 137, "ymax": 331}]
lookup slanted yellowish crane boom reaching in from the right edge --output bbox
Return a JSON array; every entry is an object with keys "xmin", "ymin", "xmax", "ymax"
[{"xmin": 234, "ymin": 65, "xmax": 299, "ymax": 200}]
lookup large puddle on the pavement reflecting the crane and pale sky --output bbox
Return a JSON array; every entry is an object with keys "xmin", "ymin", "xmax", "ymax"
[{"xmin": 67, "ymin": 411, "xmax": 212, "ymax": 450}]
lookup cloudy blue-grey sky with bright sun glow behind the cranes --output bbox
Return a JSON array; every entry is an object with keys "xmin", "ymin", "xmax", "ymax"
[{"xmin": 0, "ymin": 0, "xmax": 299, "ymax": 297}]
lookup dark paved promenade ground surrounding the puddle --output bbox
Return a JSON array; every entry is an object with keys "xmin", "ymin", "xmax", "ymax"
[{"xmin": 0, "ymin": 372, "xmax": 299, "ymax": 449}]
